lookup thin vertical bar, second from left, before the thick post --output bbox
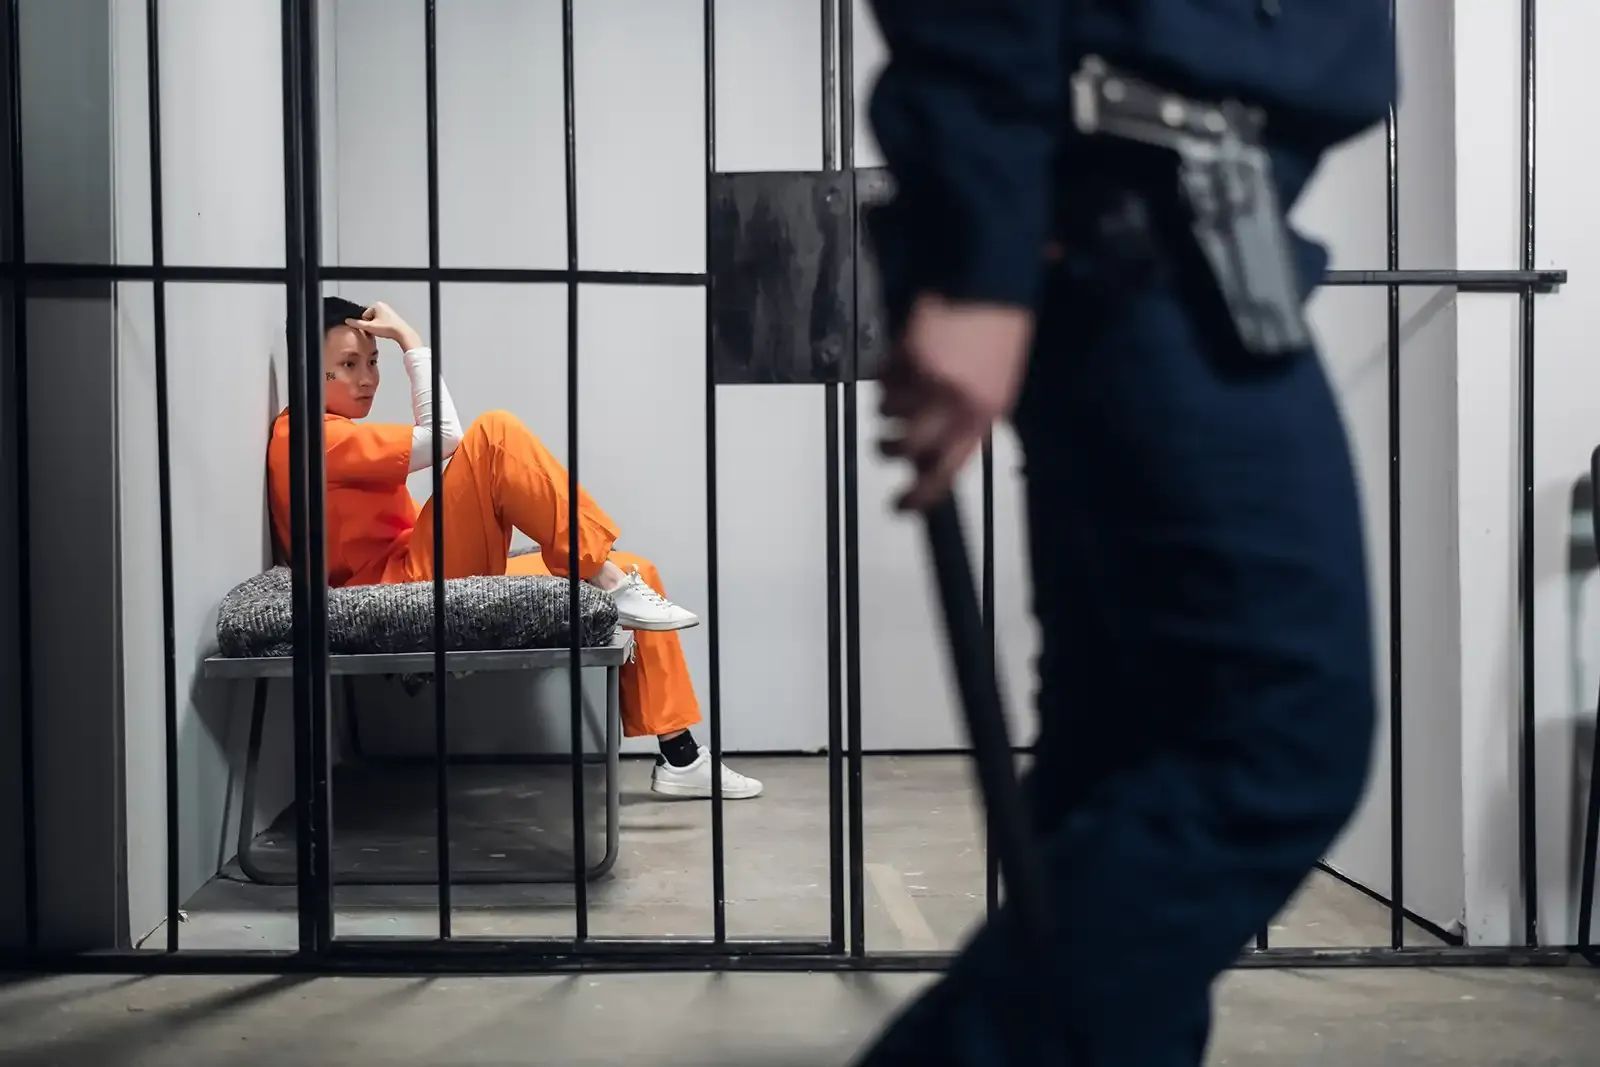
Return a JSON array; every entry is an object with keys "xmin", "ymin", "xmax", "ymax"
[{"xmin": 144, "ymin": 0, "xmax": 182, "ymax": 952}]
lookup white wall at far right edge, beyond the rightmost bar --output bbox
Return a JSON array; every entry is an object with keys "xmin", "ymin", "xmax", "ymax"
[{"xmin": 1516, "ymin": 3, "xmax": 1600, "ymax": 944}]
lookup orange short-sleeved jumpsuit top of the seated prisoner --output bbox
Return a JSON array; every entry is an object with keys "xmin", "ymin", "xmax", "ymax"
[{"xmin": 267, "ymin": 411, "xmax": 418, "ymax": 587}]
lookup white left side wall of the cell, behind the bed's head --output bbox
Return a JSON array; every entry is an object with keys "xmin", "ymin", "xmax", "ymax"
[{"xmin": 112, "ymin": 0, "xmax": 300, "ymax": 937}]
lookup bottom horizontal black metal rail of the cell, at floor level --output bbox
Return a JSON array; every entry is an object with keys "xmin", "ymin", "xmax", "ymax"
[{"xmin": 0, "ymin": 941, "xmax": 1586, "ymax": 976}]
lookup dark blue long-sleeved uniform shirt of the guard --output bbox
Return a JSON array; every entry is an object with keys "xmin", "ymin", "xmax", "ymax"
[{"xmin": 872, "ymin": 0, "xmax": 1395, "ymax": 315}]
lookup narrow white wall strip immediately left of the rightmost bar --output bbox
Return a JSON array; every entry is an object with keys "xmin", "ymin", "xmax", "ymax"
[{"xmin": 1454, "ymin": 5, "xmax": 1523, "ymax": 944}]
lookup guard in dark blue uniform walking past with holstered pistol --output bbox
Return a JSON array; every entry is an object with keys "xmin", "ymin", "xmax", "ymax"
[{"xmin": 866, "ymin": 0, "xmax": 1395, "ymax": 1067}]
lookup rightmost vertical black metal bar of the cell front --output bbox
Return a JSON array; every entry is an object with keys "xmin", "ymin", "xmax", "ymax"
[{"xmin": 1518, "ymin": 0, "xmax": 1539, "ymax": 947}]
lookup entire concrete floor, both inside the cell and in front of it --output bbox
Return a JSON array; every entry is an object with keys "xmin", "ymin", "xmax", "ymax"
[{"xmin": 12, "ymin": 757, "xmax": 1600, "ymax": 1067}]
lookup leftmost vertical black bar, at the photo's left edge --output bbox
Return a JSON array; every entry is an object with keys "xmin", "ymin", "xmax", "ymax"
[{"xmin": 6, "ymin": 0, "xmax": 38, "ymax": 950}]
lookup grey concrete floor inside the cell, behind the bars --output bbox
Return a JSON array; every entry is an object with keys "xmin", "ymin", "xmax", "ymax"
[{"xmin": 146, "ymin": 757, "xmax": 1435, "ymax": 952}]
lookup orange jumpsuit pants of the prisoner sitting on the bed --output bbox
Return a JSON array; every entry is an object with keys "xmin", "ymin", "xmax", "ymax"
[{"xmin": 387, "ymin": 411, "xmax": 701, "ymax": 737}]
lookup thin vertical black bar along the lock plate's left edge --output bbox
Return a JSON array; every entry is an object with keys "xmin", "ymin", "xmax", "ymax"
[{"xmin": 702, "ymin": 0, "xmax": 728, "ymax": 944}]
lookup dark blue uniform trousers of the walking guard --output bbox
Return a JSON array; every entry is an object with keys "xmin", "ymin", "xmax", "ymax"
[{"xmin": 867, "ymin": 187, "xmax": 1373, "ymax": 1067}]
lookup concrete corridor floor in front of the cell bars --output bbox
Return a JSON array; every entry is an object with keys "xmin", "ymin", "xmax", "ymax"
[{"xmin": 0, "ymin": 969, "xmax": 1600, "ymax": 1067}]
